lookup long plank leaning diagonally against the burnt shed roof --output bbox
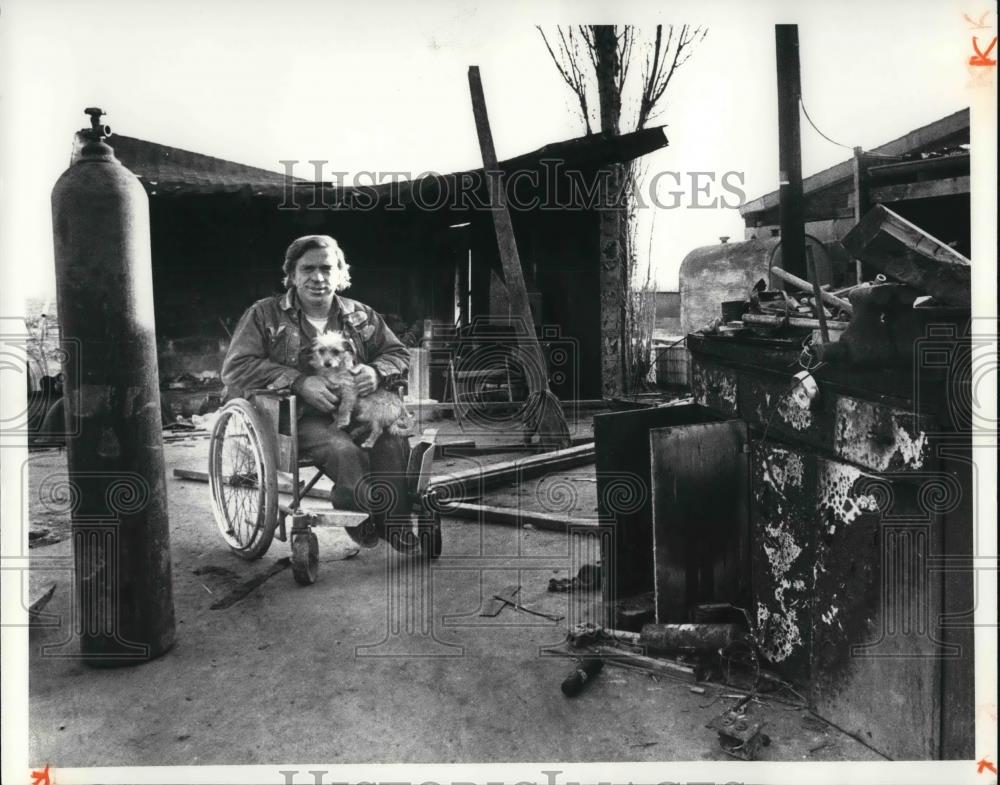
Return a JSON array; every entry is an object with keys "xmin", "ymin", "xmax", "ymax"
[{"xmin": 469, "ymin": 65, "xmax": 570, "ymax": 449}]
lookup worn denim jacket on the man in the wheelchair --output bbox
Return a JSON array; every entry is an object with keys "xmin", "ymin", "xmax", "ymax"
[{"xmin": 222, "ymin": 287, "xmax": 410, "ymax": 400}]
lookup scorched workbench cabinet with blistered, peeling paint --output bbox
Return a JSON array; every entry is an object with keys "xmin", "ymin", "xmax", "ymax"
[{"xmin": 689, "ymin": 336, "xmax": 974, "ymax": 759}]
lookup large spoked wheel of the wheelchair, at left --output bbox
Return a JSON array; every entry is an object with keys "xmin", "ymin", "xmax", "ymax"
[{"xmin": 208, "ymin": 398, "xmax": 278, "ymax": 561}]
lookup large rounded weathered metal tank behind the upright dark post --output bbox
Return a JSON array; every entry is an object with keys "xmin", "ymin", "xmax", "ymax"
[{"xmin": 680, "ymin": 237, "xmax": 850, "ymax": 335}]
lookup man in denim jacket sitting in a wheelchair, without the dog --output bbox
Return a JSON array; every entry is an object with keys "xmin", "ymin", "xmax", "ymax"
[{"xmin": 222, "ymin": 235, "xmax": 419, "ymax": 550}]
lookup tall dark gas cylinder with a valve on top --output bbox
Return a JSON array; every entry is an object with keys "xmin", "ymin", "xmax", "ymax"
[{"xmin": 52, "ymin": 109, "xmax": 174, "ymax": 665}]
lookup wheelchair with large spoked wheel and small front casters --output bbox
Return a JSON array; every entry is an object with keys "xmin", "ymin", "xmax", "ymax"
[{"xmin": 208, "ymin": 382, "xmax": 442, "ymax": 586}]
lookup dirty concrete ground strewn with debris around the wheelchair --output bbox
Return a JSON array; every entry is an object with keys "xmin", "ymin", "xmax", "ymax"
[{"xmin": 29, "ymin": 422, "xmax": 878, "ymax": 767}]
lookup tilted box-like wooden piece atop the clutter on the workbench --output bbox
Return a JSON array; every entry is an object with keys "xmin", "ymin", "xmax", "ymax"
[{"xmin": 841, "ymin": 204, "xmax": 972, "ymax": 307}]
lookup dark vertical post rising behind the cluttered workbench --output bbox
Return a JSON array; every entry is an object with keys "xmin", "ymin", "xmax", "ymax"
[{"xmin": 774, "ymin": 25, "xmax": 808, "ymax": 278}]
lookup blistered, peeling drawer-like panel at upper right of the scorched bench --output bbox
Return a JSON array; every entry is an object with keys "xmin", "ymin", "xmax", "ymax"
[{"xmin": 834, "ymin": 396, "xmax": 930, "ymax": 472}]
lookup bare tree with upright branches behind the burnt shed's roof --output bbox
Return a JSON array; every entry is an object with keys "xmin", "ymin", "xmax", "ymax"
[{"xmin": 538, "ymin": 24, "xmax": 708, "ymax": 397}]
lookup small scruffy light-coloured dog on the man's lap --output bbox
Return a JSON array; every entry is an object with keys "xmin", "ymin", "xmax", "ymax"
[{"xmin": 309, "ymin": 330, "xmax": 415, "ymax": 447}]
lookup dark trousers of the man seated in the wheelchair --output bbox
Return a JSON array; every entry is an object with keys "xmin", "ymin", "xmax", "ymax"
[{"xmin": 298, "ymin": 413, "xmax": 410, "ymax": 531}]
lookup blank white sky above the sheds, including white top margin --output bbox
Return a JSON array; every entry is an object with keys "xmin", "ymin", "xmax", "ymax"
[{"xmin": 0, "ymin": 0, "xmax": 976, "ymax": 304}]
